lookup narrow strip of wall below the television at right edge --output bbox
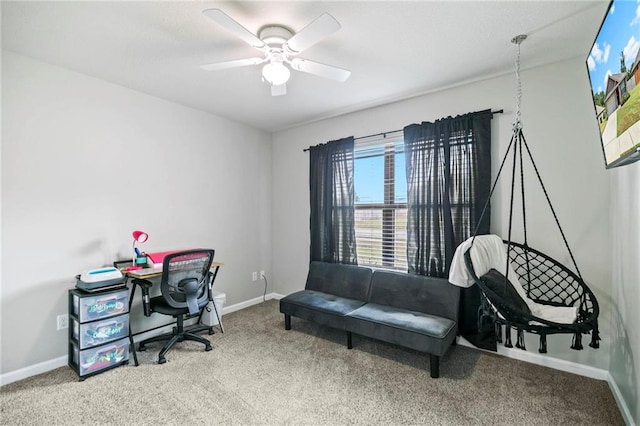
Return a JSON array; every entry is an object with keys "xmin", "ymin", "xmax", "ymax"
[{"xmin": 610, "ymin": 162, "xmax": 640, "ymax": 424}]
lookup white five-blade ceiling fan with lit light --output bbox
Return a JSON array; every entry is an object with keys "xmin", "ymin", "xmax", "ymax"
[{"xmin": 200, "ymin": 9, "xmax": 351, "ymax": 96}]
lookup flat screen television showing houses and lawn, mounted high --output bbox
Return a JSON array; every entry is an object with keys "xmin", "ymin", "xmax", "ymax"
[{"xmin": 587, "ymin": 0, "xmax": 640, "ymax": 168}]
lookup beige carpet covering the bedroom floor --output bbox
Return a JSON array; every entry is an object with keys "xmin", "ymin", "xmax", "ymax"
[{"xmin": 0, "ymin": 300, "xmax": 624, "ymax": 425}]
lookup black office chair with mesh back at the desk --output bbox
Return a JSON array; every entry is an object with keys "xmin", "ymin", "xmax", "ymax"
[{"xmin": 137, "ymin": 249, "xmax": 215, "ymax": 364}]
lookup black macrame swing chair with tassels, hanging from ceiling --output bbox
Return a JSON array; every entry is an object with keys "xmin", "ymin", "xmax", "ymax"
[{"xmin": 464, "ymin": 35, "xmax": 600, "ymax": 353}]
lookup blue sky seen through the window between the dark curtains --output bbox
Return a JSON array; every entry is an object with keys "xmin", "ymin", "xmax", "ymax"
[{"xmin": 354, "ymin": 153, "xmax": 407, "ymax": 204}]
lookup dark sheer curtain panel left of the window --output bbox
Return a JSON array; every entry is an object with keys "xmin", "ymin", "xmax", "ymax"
[{"xmin": 309, "ymin": 137, "xmax": 358, "ymax": 265}]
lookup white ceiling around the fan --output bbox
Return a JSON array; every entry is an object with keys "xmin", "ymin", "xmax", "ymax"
[{"xmin": 1, "ymin": 0, "xmax": 608, "ymax": 131}]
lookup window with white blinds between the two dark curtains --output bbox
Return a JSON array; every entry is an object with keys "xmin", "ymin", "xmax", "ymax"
[{"xmin": 354, "ymin": 131, "xmax": 407, "ymax": 271}]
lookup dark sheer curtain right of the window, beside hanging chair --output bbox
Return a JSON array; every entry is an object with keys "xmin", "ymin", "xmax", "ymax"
[{"xmin": 404, "ymin": 110, "xmax": 495, "ymax": 350}]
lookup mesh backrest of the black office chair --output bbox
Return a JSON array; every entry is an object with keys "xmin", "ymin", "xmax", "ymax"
[{"xmin": 160, "ymin": 249, "xmax": 215, "ymax": 315}]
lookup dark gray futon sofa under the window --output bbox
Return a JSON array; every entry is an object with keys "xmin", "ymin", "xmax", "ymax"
[{"xmin": 280, "ymin": 262, "xmax": 460, "ymax": 378}]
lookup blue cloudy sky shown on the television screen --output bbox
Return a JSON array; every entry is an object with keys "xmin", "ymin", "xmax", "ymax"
[{"xmin": 587, "ymin": 0, "xmax": 640, "ymax": 93}]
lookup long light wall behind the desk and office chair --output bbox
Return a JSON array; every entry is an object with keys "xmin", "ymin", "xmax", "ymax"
[{"xmin": 1, "ymin": 51, "xmax": 271, "ymax": 374}]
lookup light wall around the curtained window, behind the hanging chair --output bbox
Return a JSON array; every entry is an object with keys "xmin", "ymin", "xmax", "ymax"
[{"xmin": 272, "ymin": 59, "xmax": 612, "ymax": 370}]
